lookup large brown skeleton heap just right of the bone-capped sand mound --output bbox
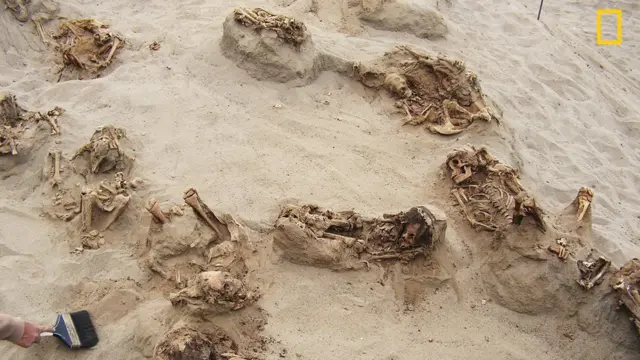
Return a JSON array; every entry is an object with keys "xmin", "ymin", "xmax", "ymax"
[{"xmin": 353, "ymin": 45, "xmax": 498, "ymax": 135}]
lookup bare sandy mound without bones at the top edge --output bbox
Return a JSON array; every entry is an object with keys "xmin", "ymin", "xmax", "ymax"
[{"xmin": 358, "ymin": 0, "xmax": 448, "ymax": 40}]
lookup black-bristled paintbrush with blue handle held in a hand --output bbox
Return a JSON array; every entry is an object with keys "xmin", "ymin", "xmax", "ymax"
[{"xmin": 40, "ymin": 310, "xmax": 98, "ymax": 349}]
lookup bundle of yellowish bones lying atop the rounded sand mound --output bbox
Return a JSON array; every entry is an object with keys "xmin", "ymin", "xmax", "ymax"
[{"xmin": 233, "ymin": 8, "xmax": 309, "ymax": 48}]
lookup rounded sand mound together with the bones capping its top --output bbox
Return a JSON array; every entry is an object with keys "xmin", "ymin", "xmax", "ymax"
[{"xmin": 220, "ymin": 8, "xmax": 320, "ymax": 84}]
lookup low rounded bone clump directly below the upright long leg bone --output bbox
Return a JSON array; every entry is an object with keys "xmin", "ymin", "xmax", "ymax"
[{"xmin": 169, "ymin": 271, "xmax": 259, "ymax": 314}]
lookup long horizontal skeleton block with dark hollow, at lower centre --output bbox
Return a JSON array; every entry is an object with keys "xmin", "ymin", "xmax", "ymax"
[{"xmin": 274, "ymin": 205, "xmax": 446, "ymax": 269}]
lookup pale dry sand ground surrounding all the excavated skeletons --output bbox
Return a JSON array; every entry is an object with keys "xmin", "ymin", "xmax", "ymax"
[{"xmin": 0, "ymin": 0, "xmax": 640, "ymax": 360}]
